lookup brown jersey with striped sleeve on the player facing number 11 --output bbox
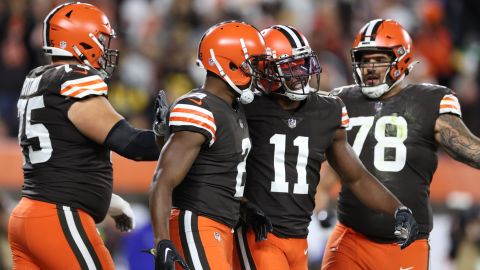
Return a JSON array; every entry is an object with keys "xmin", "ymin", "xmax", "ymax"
[{"xmin": 167, "ymin": 89, "xmax": 251, "ymax": 228}]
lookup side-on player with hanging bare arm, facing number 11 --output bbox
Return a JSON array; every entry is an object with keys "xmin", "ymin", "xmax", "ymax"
[{"xmin": 150, "ymin": 21, "xmax": 267, "ymax": 270}]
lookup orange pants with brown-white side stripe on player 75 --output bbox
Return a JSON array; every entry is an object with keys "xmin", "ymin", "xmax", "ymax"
[{"xmin": 8, "ymin": 198, "xmax": 114, "ymax": 270}]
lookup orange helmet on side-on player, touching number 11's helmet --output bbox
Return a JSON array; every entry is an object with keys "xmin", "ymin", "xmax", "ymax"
[{"xmin": 197, "ymin": 21, "xmax": 268, "ymax": 104}]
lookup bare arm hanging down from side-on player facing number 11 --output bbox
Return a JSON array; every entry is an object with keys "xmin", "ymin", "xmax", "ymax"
[{"xmin": 150, "ymin": 131, "xmax": 206, "ymax": 246}]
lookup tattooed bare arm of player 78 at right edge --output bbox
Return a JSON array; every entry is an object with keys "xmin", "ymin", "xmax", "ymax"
[{"xmin": 435, "ymin": 114, "xmax": 480, "ymax": 169}]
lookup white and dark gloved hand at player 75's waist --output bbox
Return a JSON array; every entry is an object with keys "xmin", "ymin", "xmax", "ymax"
[{"xmin": 108, "ymin": 193, "xmax": 135, "ymax": 232}]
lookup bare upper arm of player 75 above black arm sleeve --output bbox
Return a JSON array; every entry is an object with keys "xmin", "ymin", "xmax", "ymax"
[{"xmin": 68, "ymin": 96, "xmax": 123, "ymax": 144}]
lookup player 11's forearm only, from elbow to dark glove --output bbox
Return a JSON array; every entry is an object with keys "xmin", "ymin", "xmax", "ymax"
[{"xmin": 349, "ymin": 172, "xmax": 402, "ymax": 216}]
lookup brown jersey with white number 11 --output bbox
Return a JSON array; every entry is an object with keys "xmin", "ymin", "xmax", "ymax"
[{"xmin": 245, "ymin": 95, "xmax": 348, "ymax": 238}]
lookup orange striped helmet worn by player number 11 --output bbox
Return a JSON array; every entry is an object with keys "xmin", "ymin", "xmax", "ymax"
[{"xmin": 259, "ymin": 25, "xmax": 322, "ymax": 100}]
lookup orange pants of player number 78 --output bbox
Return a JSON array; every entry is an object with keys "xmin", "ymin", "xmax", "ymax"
[{"xmin": 322, "ymin": 223, "xmax": 430, "ymax": 270}]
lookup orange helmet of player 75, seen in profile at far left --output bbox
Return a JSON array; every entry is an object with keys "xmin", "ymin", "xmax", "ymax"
[{"xmin": 43, "ymin": 2, "xmax": 119, "ymax": 77}]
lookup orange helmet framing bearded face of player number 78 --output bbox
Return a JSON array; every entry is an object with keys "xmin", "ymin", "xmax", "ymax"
[{"xmin": 351, "ymin": 19, "xmax": 415, "ymax": 98}]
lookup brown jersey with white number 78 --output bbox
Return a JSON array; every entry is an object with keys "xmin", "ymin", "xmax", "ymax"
[{"xmin": 333, "ymin": 84, "xmax": 461, "ymax": 242}]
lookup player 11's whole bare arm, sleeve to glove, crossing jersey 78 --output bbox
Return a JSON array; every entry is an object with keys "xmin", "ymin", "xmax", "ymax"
[{"xmin": 327, "ymin": 129, "xmax": 402, "ymax": 216}]
